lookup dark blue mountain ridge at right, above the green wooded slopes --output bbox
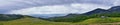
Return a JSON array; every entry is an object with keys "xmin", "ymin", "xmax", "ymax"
[{"xmin": 84, "ymin": 6, "xmax": 120, "ymax": 15}]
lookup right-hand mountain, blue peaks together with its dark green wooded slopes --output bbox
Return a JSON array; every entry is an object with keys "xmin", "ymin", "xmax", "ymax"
[{"xmin": 47, "ymin": 6, "xmax": 120, "ymax": 22}]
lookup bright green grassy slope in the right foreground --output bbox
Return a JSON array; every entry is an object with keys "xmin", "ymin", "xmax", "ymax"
[{"xmin": 77, "ymin": 17, "xmax": 120, "ymax": 25}]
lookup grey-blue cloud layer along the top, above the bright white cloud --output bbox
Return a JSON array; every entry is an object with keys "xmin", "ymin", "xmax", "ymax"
[{"xmin": 0, "ymin": 0, "xmax": 119, "ymax": 13}]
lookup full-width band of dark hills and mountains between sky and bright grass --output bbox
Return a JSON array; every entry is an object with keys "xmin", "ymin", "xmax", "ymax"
[{"xmin": 0, "ymin": 6, "xmax": 120, "ymax": 22}]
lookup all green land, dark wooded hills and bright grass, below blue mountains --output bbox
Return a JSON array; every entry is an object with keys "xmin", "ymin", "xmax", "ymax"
[{"xmin": 0, "ymin": 12, "xmax": 120, "ymax": 25}]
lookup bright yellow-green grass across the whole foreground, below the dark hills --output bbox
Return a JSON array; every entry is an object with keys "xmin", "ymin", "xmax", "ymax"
[{"xmin": 0, "ymin": 17, "xmax": 120, "ymax": 25}]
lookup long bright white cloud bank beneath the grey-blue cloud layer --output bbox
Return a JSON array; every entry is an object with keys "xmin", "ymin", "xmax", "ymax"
[{"xmin": 9, "ymin": 3, "xmax": 109, "ymax": 15}]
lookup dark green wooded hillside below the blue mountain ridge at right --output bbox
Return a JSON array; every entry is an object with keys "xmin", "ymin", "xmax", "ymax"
[{"xmin": 48, "ymin": 12, "xmax": 120, "ymax": 22}]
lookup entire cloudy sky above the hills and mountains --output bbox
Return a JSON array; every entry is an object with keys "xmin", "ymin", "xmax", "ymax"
[{"xmin": 0, "ymin": 0, "xmax": 120, "ymax": 15}]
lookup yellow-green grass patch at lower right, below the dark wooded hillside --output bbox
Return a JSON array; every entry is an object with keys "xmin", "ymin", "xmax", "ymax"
[{"xmin": 79, "ymin": 17, "xmax": 120, "ymax": 24}]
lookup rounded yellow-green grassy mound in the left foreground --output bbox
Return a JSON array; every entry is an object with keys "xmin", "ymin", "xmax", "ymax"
[{"xmin": 1, "ymin": 18, "xmax": 74, "ymax": 25}]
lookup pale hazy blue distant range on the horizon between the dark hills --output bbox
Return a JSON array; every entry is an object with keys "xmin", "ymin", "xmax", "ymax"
[{"xmin": 30, "ymin": 14, "xmax": 67, "ymax": 18}]
